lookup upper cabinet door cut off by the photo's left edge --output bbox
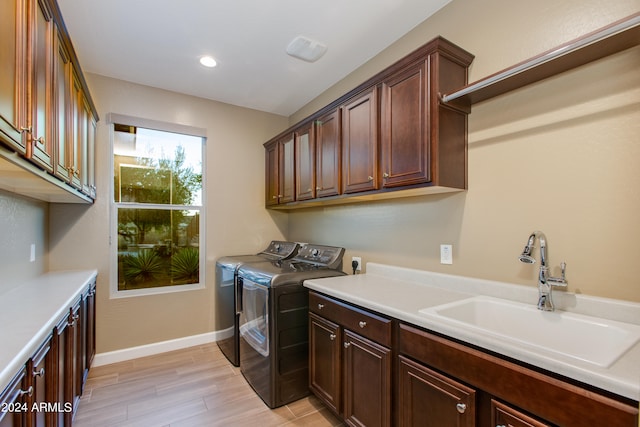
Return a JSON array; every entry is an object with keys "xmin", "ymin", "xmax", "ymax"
[{"xmin": 0, "ymin": 0, "xmax": 28, "ymax": 154}]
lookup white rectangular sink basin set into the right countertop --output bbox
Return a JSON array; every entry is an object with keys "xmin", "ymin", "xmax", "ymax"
[{"xmin": 420, "ymin": 296, "xmax": 640, "ymax": 368}]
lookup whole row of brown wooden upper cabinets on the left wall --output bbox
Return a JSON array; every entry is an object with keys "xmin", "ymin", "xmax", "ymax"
[{"xmin": 0, "ymin": 0, "xmax": 98, "ymax": 203}]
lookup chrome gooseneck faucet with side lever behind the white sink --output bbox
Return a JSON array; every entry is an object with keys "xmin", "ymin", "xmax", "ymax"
[{"xmin": 518, "ymin": 231, "xmax": 568, "ymax": 311}]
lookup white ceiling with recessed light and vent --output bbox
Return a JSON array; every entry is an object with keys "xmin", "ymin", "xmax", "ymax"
[{"xmin": 58, "ymin": 0, "xmax": 450, "ymax": 116}]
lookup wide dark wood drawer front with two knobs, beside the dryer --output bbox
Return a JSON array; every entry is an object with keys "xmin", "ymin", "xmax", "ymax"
[{"xmin": 309, "ymin": 292, "xmax": 392, "ymax": 347}]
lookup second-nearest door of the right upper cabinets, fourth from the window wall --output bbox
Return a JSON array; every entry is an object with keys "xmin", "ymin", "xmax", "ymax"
[{"xmin": 342, "ymin": 87, "xmax": 379, "ymax": 193}]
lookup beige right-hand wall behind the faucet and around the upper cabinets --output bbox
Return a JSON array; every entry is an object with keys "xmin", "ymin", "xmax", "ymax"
[{"xmin": 288, "ymin": 0, "xmax": 640, "ymax": 302}]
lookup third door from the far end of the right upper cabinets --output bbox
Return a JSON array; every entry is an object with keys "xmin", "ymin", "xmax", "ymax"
[{"xmin": 294, "ymin": 122, "xmax": 316, "ymax": 200}]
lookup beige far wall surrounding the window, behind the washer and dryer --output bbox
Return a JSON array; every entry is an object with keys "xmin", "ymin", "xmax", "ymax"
[{"xmin": 50, "ymin": 74, "xmax": 287, "ymax": 353}]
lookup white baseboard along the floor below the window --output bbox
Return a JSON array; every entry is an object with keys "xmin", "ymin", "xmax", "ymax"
[{"xmin": 91, "ymin": 331, "xmax": 226, "ymax": 367}]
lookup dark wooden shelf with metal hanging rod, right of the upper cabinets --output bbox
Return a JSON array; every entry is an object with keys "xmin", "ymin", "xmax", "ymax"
[{"xmin": 442, "ymin": 12, "xmax": 640, "ymax": 109}]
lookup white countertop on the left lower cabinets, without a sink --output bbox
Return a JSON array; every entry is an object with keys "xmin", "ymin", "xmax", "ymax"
[{"xmin": 0, "ymin": 270, "xmax": 97, "ymax": 392}]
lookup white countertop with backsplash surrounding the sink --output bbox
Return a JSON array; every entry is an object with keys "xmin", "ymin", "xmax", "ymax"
[{"xmin": 304, "ymin": 263, "xmax": 640, "ymax": 400}]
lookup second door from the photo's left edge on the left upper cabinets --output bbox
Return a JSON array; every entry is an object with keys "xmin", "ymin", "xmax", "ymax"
[{"xmin": 26, "ymin": 0, "xmax": 54, "ymax": 171}]
